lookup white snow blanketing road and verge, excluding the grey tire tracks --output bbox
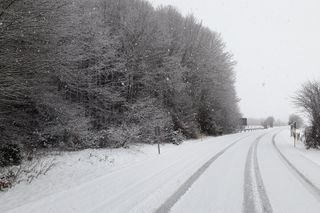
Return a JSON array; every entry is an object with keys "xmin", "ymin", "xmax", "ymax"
[{"xmin": 0, "ymin": 128, "xmax": 320, "ymax": 213}]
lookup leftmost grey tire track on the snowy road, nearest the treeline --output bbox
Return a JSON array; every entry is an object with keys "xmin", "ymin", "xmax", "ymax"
[{"xmin": 155, "ymin": 135, "xmax": 250, "ymax": 213}]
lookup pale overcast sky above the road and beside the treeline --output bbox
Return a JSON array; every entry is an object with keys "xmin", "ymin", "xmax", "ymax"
[{"xmin": 149, "ymin": 0, "xmax": 320, "ymax": 121}]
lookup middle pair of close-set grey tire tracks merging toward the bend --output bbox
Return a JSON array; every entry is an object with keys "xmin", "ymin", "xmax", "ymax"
[{"xmin": 242, "ymin": 133, "xmax": 273, "ymax": 213}]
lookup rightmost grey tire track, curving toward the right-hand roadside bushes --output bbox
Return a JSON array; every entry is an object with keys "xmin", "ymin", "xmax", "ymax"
[{"xmin": 272, "ymin": 133, "xmax": 320, "ymax": 200}]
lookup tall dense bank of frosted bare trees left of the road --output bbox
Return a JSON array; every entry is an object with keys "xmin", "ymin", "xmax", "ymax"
[{"xmin": 0, "ymin": 0, "xmax": 239, "ymax": 162}]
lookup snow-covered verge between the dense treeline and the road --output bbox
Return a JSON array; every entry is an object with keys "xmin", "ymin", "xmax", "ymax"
[{"xmin": 0, "ymin": 133, "xmax": 250, "ymax": 212}]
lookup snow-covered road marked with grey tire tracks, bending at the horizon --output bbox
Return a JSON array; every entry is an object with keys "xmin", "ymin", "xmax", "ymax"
[{"xmin": 0, "ymin": 128, "xmax": 320, "ymax": 213}]
